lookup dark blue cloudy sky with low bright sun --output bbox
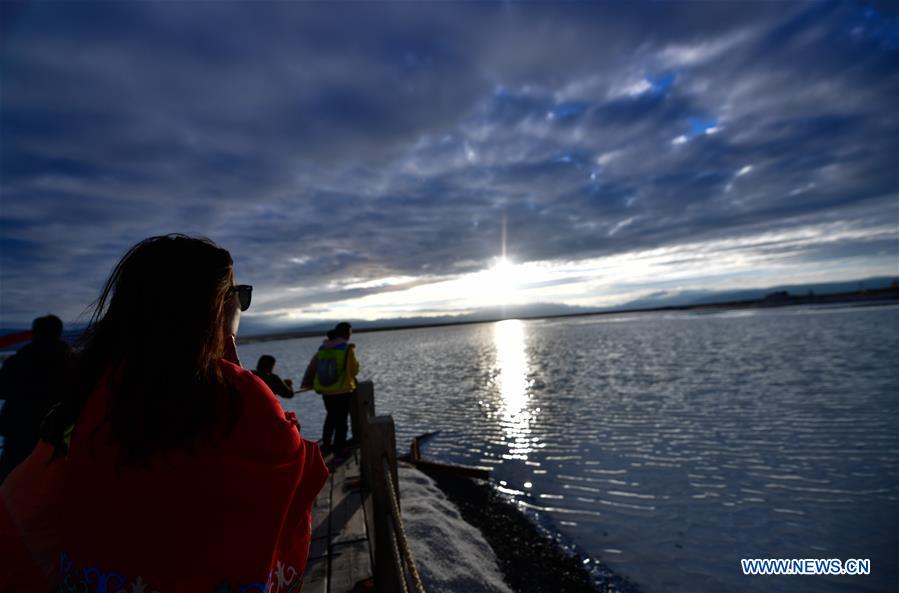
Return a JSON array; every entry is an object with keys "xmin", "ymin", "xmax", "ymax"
[{"xmin": 0, "ymin": 1, "xmax": 899, "ymax": 327}]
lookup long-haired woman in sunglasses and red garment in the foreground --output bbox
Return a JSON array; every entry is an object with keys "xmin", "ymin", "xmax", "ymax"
[{"xmin": 0, "ymin": 235, "xmax": 328, "ymax": 593}]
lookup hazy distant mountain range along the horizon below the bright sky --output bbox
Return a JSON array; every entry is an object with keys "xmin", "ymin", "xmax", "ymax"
[{"xmin": 0, "ymin": 276, "xmax": 896, "ymax": 341}]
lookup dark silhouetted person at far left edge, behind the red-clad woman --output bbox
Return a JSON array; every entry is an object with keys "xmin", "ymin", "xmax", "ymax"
[{"xmin": 0, "ymin": 315, "xmax": 71, "ymax": 482}]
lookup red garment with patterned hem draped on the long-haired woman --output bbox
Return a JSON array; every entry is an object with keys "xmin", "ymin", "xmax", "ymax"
[{"xmin": 0, "ymin": 361, "xmax": 328, "ymax": 593}]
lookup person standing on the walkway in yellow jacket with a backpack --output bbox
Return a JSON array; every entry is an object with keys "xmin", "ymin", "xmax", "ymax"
[{"xmin": 301, "ymin": 321, "xmax": 359, "ymax": 457}]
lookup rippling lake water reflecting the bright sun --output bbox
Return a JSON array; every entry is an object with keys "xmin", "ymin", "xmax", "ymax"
[{"xmin": 240, "ymin": 307, "xmax": 899, "ymax": 593}]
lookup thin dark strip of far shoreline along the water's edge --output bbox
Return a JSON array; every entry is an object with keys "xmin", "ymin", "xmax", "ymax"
[{"xmin": 237, "ymin": 286, "xmax": 899, "ymax": 344}]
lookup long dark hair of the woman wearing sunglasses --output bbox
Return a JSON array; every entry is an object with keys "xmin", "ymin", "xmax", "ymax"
[{"xmin": 44, "ymin": 234, "xmax": 234, "ymax": 461}]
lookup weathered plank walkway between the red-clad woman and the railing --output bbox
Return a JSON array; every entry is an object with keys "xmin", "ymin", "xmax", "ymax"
[{"xmin": 303, "ymin": 449, "xmax": 374, "ymax": 593}]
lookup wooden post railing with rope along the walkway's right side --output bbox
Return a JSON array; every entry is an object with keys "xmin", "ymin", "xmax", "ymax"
[{"xmin": 350, "ymin": 381, "xmax": 424, "ymax": 593}]
